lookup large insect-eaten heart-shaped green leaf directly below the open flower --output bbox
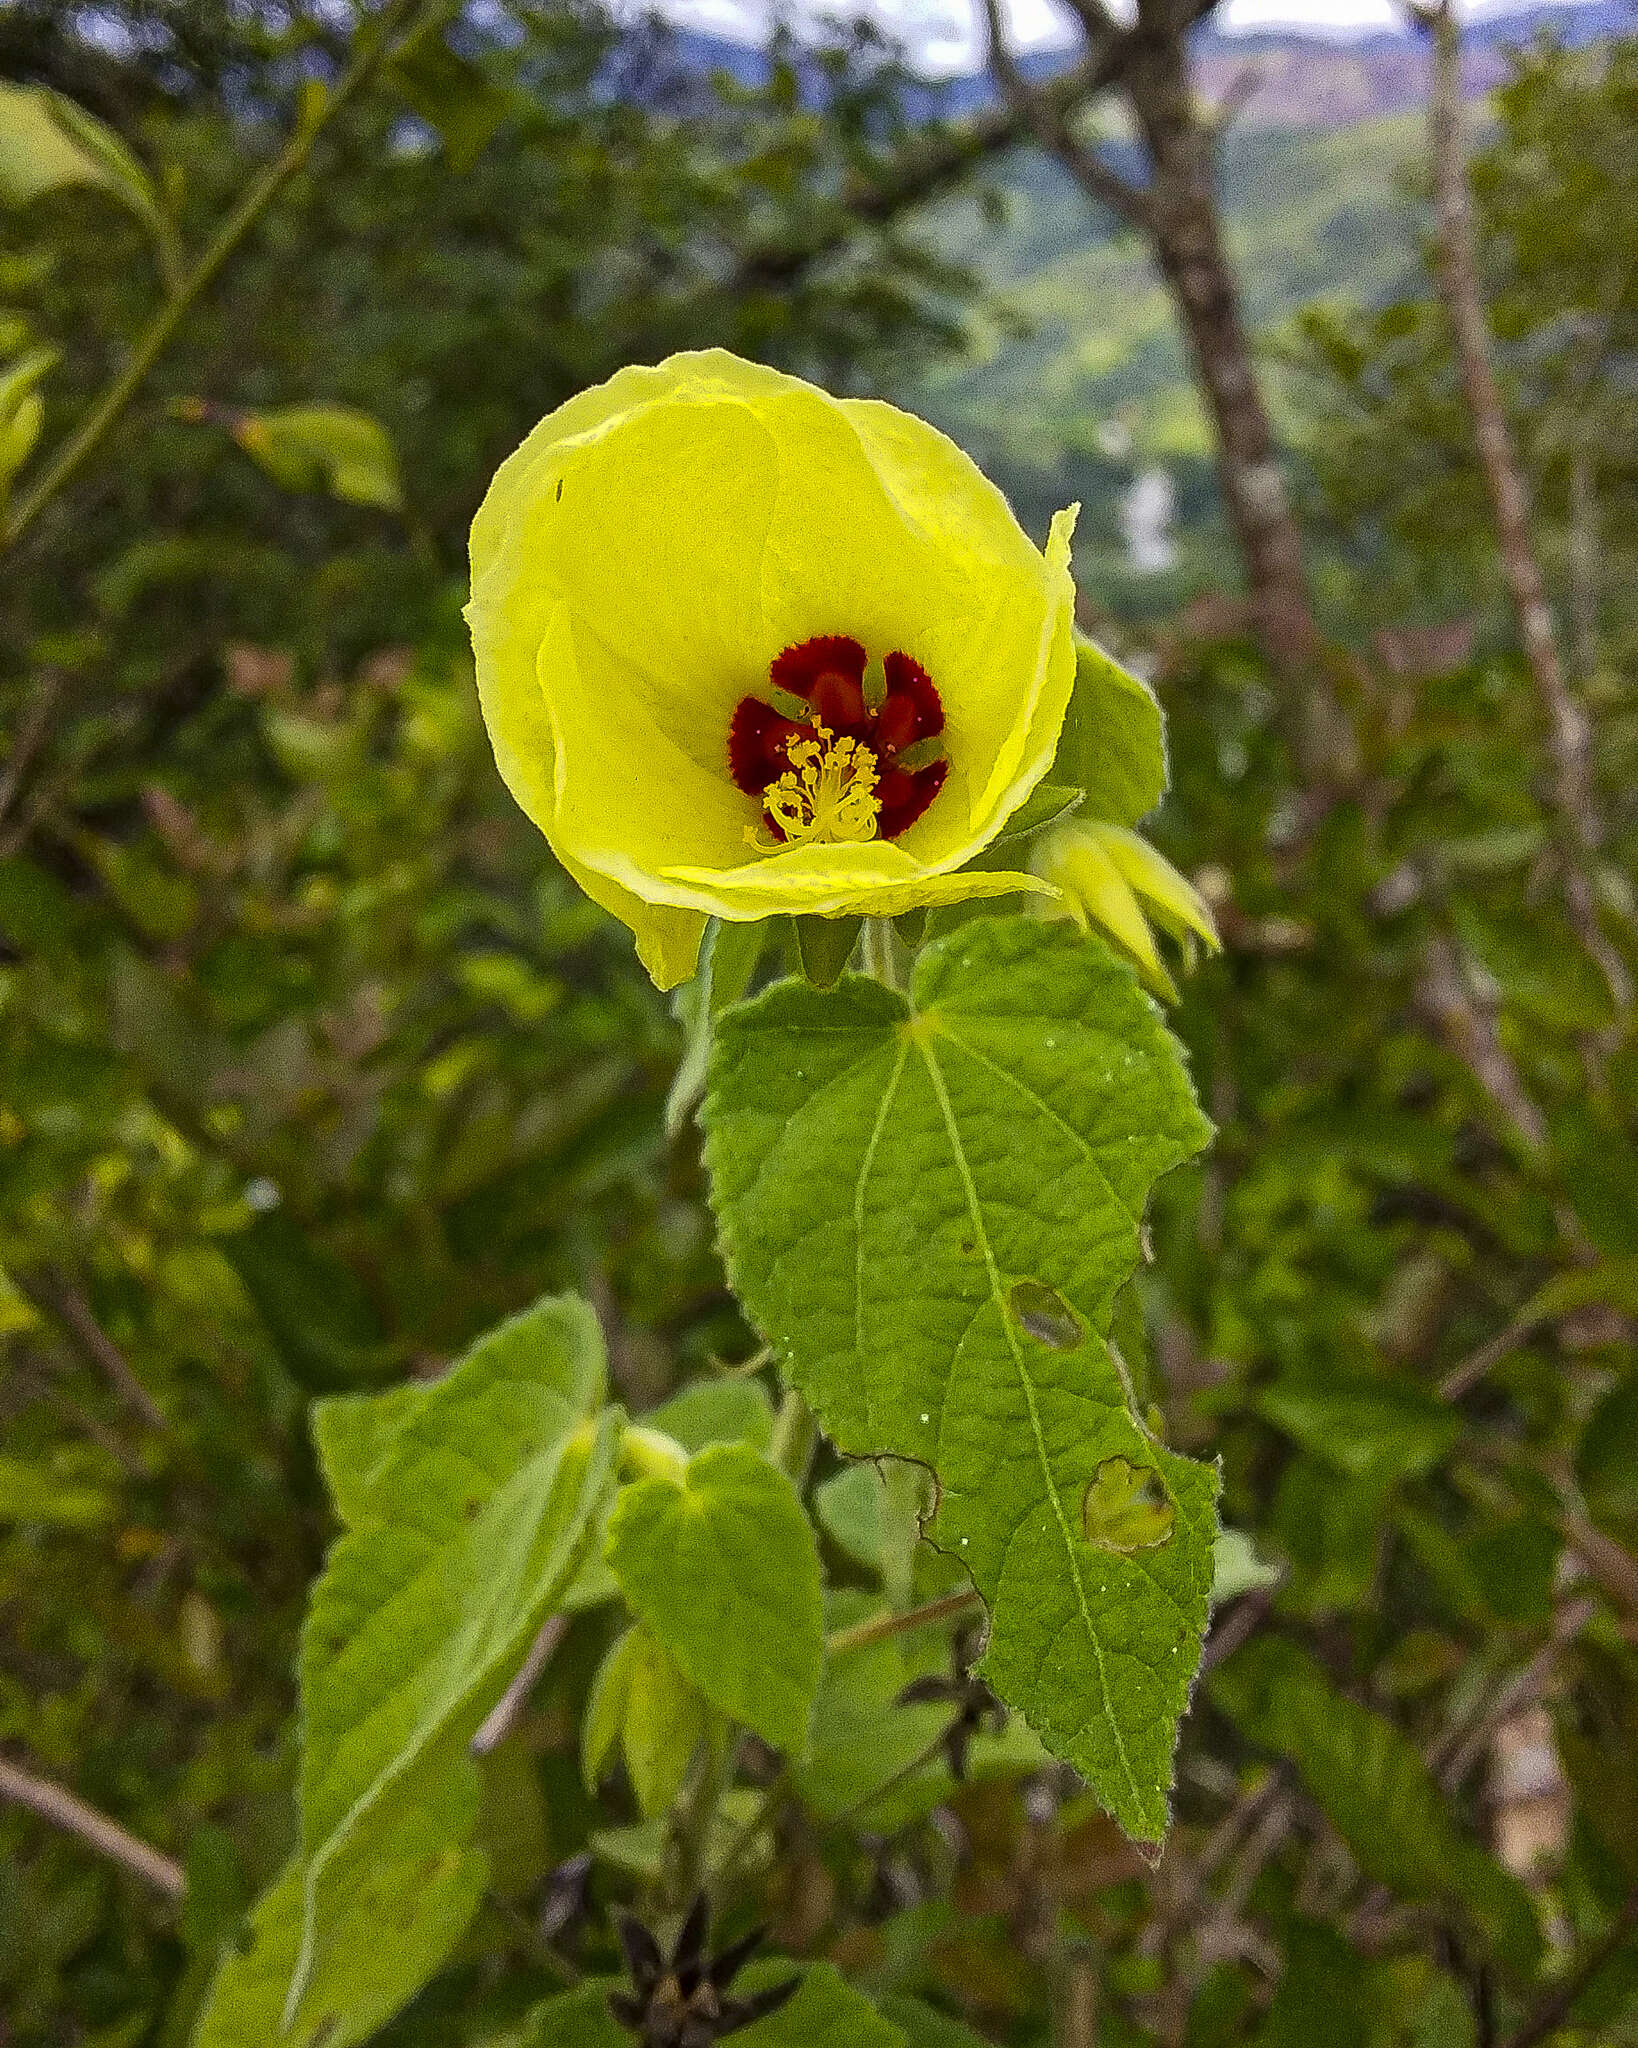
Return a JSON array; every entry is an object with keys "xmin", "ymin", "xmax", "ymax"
[{"xmin": 706, "ymin": 918, "xmax": 1216, "ymax": 1841}]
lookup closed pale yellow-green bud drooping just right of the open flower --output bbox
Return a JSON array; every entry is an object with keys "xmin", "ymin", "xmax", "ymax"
[{"xmin": 1030, "ymin": 817, "xmax": 1218, "ymax": 1004}]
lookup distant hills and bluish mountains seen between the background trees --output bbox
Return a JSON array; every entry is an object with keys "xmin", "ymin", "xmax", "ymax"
[{"xmin": 651, "ymin": 0, "xmax": 1638, "ymax": 602}]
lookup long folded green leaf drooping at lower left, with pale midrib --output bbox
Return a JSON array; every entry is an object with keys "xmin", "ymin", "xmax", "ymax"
[{"xmin": 293, "ymin": 1298, "xmax": 618, "ymax": 1997}]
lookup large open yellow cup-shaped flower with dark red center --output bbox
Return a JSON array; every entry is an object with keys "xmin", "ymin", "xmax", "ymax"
[{"xmin": 467, "ymin": 348, "xmax": 1075, "ymax": 987}]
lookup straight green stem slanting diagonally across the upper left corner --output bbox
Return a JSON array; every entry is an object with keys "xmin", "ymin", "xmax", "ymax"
[{"xmin": 0, "ymin": 0, "xmax": 442, "ymax": 547}]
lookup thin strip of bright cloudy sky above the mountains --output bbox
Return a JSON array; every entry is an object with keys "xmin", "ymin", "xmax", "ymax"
[{"xmin": 634, "ymin": 0, "xmax": 1588, "ymax": 72}]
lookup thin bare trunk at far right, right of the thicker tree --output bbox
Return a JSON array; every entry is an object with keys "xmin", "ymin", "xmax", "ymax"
[{"xmin": 1411, "ymin": 0, "xmax": 1632, "ymax": 1010}]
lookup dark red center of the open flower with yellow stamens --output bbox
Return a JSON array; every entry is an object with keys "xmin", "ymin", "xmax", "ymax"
[{"xmin": 729, "ymin": 633, "xmax": 950, "ymax": 842}]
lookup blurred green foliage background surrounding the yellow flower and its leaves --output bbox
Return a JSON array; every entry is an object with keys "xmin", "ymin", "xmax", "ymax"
[{"xmin": 0, "ymin": 0, "xmax": 1638, "ymax": 2048}]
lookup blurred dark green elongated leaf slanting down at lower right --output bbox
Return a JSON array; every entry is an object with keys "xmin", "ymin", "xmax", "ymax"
[{"xmin": 1212, "ymin": 1636, "xmax": 1540, "ymax": 1972}]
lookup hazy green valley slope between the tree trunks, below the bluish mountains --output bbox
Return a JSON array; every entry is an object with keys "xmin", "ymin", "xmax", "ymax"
[{"xmin": 897, "ymin": 115, "xmax": 1427, "ymax": 614}]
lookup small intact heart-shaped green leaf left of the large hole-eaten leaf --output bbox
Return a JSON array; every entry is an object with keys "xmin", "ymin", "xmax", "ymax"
[{"xmin": 606, "ymin": 1444, "xmax": 825, "ymax": 1755}]
